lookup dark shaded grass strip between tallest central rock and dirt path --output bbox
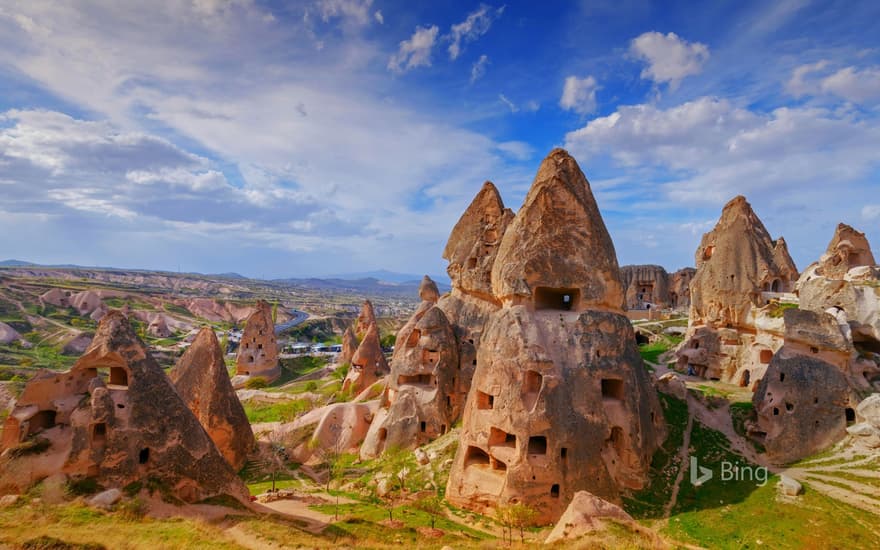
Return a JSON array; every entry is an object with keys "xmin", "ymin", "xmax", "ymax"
[{"xmin": 623, "ymin": 393, "xmax": 688, "ymax": 518}]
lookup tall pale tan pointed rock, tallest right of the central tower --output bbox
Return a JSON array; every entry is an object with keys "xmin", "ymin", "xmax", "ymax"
[{"xmin": 677, "ymin": 196, "xmax": 797, "ymax": 387}]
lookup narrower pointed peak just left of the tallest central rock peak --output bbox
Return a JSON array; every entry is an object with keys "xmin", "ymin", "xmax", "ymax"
[{"xmin": 443, "ymin": 181, "xmax": 513, "ymax": 302}]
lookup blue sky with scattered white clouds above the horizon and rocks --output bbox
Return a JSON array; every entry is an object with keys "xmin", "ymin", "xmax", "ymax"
[{"xmin": 0, "ymin": 0, "xmax": 880, "ymax": 277}]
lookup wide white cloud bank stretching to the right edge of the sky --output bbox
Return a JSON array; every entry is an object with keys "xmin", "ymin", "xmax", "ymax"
[{"xmin": 565, "ymin": 97, "xmax": 880, "ymax": 204}]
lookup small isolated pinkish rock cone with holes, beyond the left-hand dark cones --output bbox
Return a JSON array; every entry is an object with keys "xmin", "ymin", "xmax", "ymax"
[{"xmin": 235, "ymin": 300, "xmax": 281, "ymax": 382}]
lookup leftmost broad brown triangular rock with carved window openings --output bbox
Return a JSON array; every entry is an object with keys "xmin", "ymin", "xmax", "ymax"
[{"xmin": 0, "ymin": 311, "xmax": 247, "ymax": 502}]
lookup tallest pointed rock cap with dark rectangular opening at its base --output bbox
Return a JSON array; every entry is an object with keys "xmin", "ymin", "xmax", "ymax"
[{"xmin": 492, "ymin": 149, "xmax": 623, "ymax": 311}]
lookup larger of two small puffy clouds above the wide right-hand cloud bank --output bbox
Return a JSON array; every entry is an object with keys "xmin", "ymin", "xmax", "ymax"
[{"xmin": 630, "ymin": 31, "xmax": 709, "ymax": 89}]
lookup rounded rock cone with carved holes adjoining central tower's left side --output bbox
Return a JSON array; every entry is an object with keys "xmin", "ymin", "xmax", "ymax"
[{"xmin": 361, "ymin": 279, "xmax": 463, "ymax": 458}]
